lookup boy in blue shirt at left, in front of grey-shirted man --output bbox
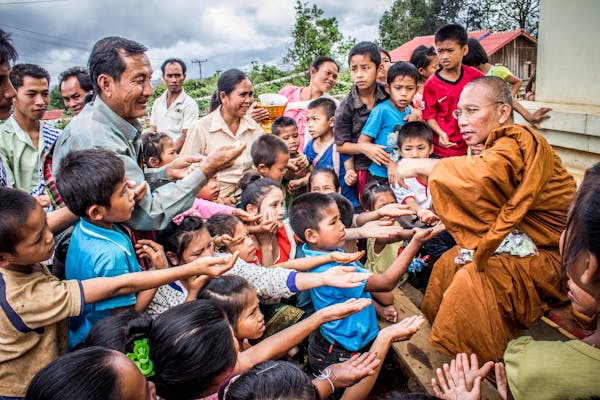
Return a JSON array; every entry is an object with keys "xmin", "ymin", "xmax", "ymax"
[{"xmin": 56, "ymin": 149, "xmax": 176, "ymax": 348}]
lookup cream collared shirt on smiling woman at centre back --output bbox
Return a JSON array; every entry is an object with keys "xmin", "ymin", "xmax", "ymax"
[{"xmin": 181, "ymin": 107, "xmax": 264, "ymax": 184}]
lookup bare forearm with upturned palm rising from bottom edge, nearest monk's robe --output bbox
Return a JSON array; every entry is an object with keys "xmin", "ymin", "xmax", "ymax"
[{"xmin": 342, "ymin": 315, "xmax": 425, "ymax": 400}]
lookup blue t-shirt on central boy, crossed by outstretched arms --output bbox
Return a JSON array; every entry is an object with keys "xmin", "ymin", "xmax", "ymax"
[{"xmin": 302, "ymin": 244, "xmax": 379, "ymax": 351}]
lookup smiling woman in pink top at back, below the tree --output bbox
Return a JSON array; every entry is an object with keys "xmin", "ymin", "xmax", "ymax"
[{"xmin": 279, "ymin": 56, "xmax": 340, "ymax": 154}]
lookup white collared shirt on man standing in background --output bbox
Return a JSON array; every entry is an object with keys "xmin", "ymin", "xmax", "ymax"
[{"xmin": 150, "ymin": 90, "xmax": 200, "ymax": 141}]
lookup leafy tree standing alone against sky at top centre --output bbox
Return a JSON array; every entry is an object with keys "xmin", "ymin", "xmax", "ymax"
[{"xmin": 283, "ymin": 0, "xmax": 342, "ymax": 71}]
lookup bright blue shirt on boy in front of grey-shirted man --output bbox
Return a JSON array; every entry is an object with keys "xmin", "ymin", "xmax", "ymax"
[{"xmin": 65, "ymin": 219, "xmax": 141, "ymax": 349}]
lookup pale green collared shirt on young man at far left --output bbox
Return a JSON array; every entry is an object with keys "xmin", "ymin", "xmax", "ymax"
[{"xmin": 0, "ymin": 116, "xmax": 61, "ymax": 196}]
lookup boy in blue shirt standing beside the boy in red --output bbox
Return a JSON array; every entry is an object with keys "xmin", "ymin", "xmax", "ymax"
[{"xmin": 358, "ymin": 62, "xmax": 419, "ymax": 183}]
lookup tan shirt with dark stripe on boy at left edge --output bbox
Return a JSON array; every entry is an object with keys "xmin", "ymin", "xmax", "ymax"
[{"xmin": 0, "ymin": 265, "xmax": 84, "ymax": 397}]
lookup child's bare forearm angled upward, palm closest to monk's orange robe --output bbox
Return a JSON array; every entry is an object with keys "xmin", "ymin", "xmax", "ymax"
[{"xmin": 365, "ymin": 225, "xmax": 445, "ymax": 292}]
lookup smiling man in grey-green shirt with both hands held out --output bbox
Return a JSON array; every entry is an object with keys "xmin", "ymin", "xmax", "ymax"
[{"xmin": 52, "ymin": 37, "xmax": 244, "ymax": 230}]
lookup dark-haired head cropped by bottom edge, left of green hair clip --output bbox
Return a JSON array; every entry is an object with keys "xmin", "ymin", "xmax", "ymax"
[{"xmin": 25, "ymin": 347, "xmax": 156, "ymax": 400}]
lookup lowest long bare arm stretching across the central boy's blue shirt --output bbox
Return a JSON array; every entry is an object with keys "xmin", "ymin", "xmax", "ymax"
[{"xmin": 233, "ymin": 299, "xmax": 371, "ymax": 374}]
